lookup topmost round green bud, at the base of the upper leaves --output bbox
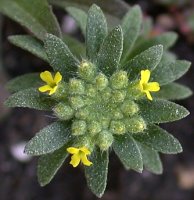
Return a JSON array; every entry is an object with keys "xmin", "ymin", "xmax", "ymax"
[{"xmin": 78, "ymin": 60, "xmax": 96, "ymax": 81}]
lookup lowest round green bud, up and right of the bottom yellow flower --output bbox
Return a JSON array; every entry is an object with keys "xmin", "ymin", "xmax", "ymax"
[{"xmin": 96, "ymin": 130, "xmax": 114, "ymax": 151}]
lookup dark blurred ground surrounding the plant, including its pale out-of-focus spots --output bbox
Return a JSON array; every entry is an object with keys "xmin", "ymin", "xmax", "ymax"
[{"xmin": 0, "ymin": 0, "xmax": 194, "ymax": 200}]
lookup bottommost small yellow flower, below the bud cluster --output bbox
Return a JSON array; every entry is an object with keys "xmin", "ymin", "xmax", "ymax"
[{"xmin": 67, "ymin": 147, "xmax": 92, "ymax": 167}]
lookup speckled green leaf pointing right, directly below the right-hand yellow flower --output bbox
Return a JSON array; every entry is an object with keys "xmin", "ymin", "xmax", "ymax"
[{"xmin": 138, "ymin": 99, "xmax": 189, "ymax": 123}]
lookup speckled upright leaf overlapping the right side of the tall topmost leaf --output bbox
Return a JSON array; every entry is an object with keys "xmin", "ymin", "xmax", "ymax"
[{"xmin": 97, "ymin": 26, "xmax": 123, "ymax": 75}]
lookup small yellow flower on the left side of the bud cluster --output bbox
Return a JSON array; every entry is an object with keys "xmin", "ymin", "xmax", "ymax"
[{"xmin": 39, "ymin": 71, "xmax": 62, "ymax": 95}]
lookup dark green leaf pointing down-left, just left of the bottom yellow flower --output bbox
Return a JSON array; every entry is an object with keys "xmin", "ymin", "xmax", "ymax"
[{"xmin": 37, "ymin": 146, "xmax": 68, "ymax": 186}]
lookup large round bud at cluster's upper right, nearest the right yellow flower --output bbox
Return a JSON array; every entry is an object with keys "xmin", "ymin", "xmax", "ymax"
[{"xmin": 110, "ymin": 71, "xmax": 128, "ymax": 89}]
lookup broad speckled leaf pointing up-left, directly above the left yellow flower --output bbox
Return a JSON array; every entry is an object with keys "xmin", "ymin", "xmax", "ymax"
[{"xmin": 44, "ymin": 34, "xmax": 79, "ymax": 80}]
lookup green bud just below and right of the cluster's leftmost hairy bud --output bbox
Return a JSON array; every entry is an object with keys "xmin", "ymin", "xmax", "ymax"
[{"xmin": 71, "ymin": 120, "xmax": 86, "ymax": 136}]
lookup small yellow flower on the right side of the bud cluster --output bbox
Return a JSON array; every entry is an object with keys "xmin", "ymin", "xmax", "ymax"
[{"xmin": 139, "ymin": 69, "xmax": 160, "ymax": 100}]
